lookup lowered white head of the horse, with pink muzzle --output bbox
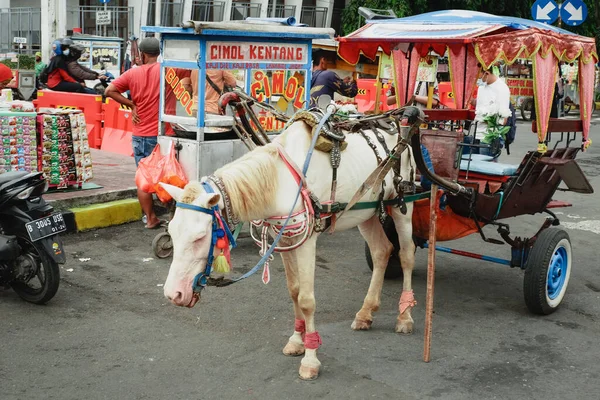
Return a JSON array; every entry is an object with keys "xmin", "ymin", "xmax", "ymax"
[{"xmin": 161, "ymin": 182, "xmax": 221, "ymax": 307}]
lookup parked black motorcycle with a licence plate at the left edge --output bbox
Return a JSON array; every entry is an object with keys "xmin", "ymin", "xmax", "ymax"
[{"xmin": 0, "ymin": 171, "xmax": 67, "ymax": 304}]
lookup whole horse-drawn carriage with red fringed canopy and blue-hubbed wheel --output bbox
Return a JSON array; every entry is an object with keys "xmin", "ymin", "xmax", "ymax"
[{"xmin": 339, "ymin": 10, "xmax": 598, "ymax": 328}]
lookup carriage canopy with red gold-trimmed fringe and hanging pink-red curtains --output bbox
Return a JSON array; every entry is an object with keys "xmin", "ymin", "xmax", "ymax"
[{"xmin": 338, "ymin": 10, "xmax": 598, "ymax": 147}]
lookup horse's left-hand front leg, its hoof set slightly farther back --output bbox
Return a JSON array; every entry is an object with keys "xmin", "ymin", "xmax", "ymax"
[{"xmin": 281, "ymin": 251, "xmax": 306, "ymax": 356}]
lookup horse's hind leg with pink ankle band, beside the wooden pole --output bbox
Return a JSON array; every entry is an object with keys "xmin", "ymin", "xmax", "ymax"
[{"xmin": 392, "ymin": 203, "xmax": 417, "ymax": 333}]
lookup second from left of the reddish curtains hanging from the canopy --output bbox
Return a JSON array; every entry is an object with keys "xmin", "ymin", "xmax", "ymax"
[{"xmin": 448, "ymin": 44, "xmax": 480, "ymax": 108}]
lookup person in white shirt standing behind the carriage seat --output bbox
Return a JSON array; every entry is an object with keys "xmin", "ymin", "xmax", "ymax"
[{"xmin": 465, "ymin": 70, "xmax": 512, "ymax": 155}]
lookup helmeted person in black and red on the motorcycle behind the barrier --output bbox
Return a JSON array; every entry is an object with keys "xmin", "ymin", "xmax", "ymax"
[{"xmin": 46, "ymin": 38, "xmax": 87, "ymax": 93}]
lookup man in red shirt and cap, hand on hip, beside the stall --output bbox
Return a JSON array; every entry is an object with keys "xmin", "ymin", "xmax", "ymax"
[{"xmin": 105, "ymin": 38, "xmax": 161, "ymax": 229}]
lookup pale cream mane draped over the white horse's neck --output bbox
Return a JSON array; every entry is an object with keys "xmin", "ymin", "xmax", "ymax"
[{"xmin": 215, "ymin": 144, "xmax": 279, "ymax": 221}]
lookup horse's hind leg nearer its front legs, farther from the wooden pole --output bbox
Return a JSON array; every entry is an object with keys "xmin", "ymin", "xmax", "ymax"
[{"xmin": 352, "ymin": 215, "xmax": 394, "ymax": 330}]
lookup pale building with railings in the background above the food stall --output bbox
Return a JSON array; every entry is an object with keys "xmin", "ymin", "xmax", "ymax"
[{"xmin": 0, "ymin": 0, "xmax": 347, "ymax": 58}]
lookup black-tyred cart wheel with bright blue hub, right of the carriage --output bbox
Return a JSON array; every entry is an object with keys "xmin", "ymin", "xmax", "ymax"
[{"xmin": 523, "ymin": 228, "xmax": 572, "ymax": 315}]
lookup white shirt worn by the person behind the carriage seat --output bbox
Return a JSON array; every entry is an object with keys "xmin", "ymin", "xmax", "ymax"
[{"xmin": 475, "ymin": 79, "xmax": 512, "ymax": 140}]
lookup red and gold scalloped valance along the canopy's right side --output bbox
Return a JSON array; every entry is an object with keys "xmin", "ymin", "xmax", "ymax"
[{"xmin": 473, "ymin": 28, "xmax": 598, "ymax": 67}]
